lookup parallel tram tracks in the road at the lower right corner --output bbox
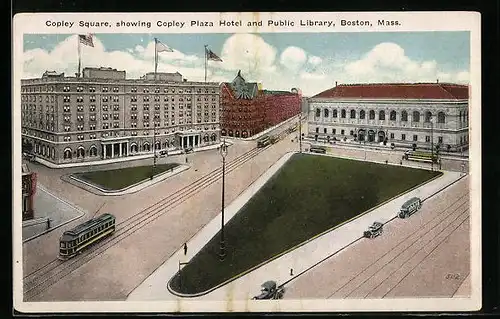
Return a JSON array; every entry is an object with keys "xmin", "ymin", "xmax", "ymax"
[{"xmin": 327, "ymin": 192, "xmax": 469, "ymax": 299}]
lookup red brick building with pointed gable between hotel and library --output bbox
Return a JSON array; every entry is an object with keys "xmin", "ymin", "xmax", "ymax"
[{"xmin": 220, "ymin": 71, "xmax": 302, "ymax": 138}]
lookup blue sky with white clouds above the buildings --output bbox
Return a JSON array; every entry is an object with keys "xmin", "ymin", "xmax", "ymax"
[{"xmin": 24, "ymin": 32, "xmax": 470, "ymax": 95}]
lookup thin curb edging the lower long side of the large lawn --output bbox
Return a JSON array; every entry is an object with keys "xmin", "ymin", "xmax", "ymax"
[{"xmin": 167, "ymin": 151, "xmax": 443, "ymax": 298}]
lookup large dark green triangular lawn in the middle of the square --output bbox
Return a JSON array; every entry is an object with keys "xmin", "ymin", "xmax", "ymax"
[{"xmin": 171, "ymin": 154, "xmax": 442, "ymax": 294}]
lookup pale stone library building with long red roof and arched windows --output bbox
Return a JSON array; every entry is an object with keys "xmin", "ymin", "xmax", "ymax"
[{"xmin": 308, "ymin": 82, "xmax": 469, "ymax": 152}]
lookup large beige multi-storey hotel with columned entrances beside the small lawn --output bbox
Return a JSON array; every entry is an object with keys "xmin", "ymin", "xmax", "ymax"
[{"xmin": 21, "ymin": 68, "xmax": 220, "ymax": 166}]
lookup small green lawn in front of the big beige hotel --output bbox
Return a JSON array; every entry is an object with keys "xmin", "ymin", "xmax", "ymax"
[{"xmin": 73, "ymin": 163, "xmax": 179, "ymax": 190}]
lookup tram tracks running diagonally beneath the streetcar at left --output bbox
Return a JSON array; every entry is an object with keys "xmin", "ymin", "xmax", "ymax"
[{"xmin": 23, "ymin": 130, "xmax": 289, "ymax": 300}]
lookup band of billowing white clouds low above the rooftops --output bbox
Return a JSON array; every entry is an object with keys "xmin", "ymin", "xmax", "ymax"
[{"xmin": 23, "ymin": 34, "xmax": 470, "ymax": 96}]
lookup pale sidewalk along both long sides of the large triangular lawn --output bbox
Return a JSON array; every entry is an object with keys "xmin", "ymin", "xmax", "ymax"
[{"xmin": 127, "ymin": 153, "xmax": 460, "ymax": 304}]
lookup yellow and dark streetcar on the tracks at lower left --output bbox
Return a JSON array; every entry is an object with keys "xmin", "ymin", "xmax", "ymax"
[{"xmin": 58, "ymin": 213, "xmax": 116, "ymax": 260}]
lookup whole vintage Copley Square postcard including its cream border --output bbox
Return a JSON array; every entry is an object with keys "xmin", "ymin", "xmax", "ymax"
[{"xmin": 12, "ymin": 12, "xmax": 481, "ymax": 313}]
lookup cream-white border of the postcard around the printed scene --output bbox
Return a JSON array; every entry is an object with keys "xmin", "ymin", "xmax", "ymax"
[{"xmin": 12, "ymin": 12, "xmax": 482, "ymax": 313}]
